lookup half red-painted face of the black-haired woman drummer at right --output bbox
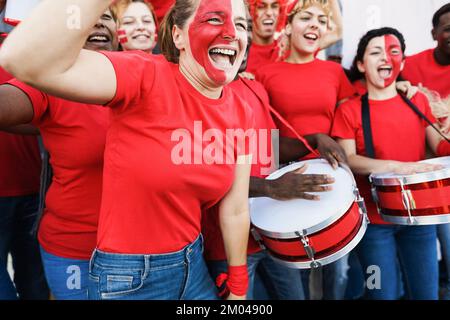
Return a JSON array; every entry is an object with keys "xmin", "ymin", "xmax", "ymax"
[{"xmin": 361, "ymin": 35, "xmax": 404, "ymax": 88}]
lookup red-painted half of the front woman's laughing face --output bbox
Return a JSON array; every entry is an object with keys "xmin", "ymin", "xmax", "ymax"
[{"xmin": 189, "ymin": 0, "xmax": 236, "ymax": 83}]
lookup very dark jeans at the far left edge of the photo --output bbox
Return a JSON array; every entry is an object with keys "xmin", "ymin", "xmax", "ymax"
[{"xmin": 0, "ymin": 195, "xmax": 49, "ymax": 300}]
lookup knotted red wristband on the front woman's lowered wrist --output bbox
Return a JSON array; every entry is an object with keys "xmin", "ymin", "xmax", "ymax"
[{"xmin": 216, "ymin": 265, "xmax": 248, "ymax": 299}]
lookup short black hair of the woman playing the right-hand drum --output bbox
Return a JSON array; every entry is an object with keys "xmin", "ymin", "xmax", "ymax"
[{"xmin": 349, "ymin": 27, "xmax": 406, "ymax": 82}]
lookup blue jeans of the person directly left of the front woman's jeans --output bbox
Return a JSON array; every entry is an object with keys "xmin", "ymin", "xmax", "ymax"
[{"xmin": 41, "ymin": 247, "xmax": 89, "ymax": 300}]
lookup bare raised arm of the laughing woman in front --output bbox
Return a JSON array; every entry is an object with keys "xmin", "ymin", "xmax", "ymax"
[{"xmin": 0, "ymin": 0, "xmax": 116, "ymax": 104}]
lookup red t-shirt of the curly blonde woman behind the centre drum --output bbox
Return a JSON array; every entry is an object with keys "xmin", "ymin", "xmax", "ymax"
[{"xmin": 256, "ymin": 59, "xmax": 355, "ymax": 138}]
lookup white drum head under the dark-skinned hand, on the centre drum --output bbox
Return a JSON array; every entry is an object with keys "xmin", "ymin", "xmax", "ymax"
[{"xmin": 250, "ymin": 159, "xmax": 355, "ymax": 239}]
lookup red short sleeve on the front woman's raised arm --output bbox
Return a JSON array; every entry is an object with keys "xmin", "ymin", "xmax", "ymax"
[{"xmin": 101, "ymin": 51, "xmax": 156, "ymax": 108}]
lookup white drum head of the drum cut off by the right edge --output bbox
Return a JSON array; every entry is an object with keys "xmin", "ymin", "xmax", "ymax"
[{"xmin": 371, "ymin": 157, "xmax": 450, "ymax": 186}]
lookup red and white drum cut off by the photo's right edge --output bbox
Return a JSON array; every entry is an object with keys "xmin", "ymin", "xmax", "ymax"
[{"xmin": 370, "ymin": 157, "xmax": 450, "ymax": 225}]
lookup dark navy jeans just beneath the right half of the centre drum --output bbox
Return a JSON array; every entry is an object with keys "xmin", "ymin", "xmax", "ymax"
[{"xmin": 300, "ymin": 255, "xmax": 349, "ymax": 300}]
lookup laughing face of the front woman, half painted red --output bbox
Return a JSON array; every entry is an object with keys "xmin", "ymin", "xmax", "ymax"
[{"xmin": 189, "ymin": 0, "xmax": 247, "ymax": 85}]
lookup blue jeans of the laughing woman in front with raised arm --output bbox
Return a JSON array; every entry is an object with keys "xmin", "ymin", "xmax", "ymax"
[{"xmin": 89, "ymin": 236, "xmax": 218, "ymax": 300}]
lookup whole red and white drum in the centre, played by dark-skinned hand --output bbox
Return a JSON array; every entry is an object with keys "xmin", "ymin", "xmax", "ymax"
[{"xmin": 250, "ymin": 159, "xmax": 368, "ymax": 269}]
